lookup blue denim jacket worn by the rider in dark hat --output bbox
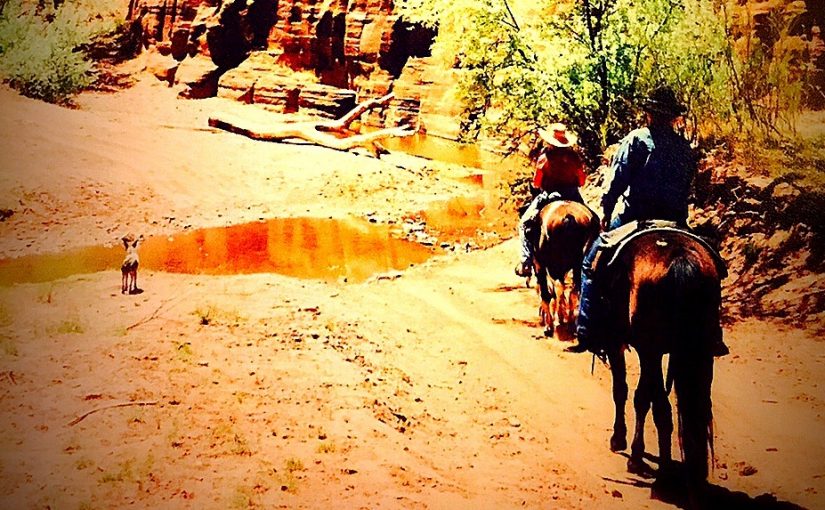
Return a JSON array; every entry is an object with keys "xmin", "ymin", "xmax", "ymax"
[{"xmin": 602, "ymin": 126, "xmax": 697, "ymax": 224}]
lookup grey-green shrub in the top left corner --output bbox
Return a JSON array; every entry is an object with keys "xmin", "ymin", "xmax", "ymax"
[{"xmin": 0, "ymin": 0, "xmax": 114, "ymax": 102}]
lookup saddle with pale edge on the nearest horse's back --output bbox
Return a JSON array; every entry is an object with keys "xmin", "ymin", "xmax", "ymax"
[{"xmin": 592, "ymin": 220, "xmax": 728, "ymax": 279}]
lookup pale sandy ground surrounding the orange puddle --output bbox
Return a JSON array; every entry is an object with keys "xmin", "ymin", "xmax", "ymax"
[{"xmin": 0, "ymin": 83, "xmax": 825, "ymax": 508}]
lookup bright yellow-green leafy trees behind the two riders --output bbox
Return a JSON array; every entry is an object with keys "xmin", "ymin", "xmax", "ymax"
[{"xmin": 400, "ymin": 0, "xmax": 812, "ymax": 165}]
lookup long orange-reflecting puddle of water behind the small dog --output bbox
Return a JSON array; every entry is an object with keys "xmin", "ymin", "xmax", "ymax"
[{"xmin": 0, "ymin": 218, "xmax": 433, "ymax": 286}]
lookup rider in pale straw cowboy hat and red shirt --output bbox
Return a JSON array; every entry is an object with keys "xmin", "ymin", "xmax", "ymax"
[{"xmin": 515, "ymin": 124, "xmax": 586, "ymax": 278}]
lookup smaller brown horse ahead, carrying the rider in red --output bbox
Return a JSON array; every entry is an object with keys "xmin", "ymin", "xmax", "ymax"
[{"xmin": 534, "ymin": 200, "xmax": 600, "ymax": 336}]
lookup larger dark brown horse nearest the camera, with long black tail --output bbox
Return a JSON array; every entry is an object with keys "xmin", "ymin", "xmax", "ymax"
[{"xmin": 605, "ymin": 230, "xmax": 723, "ymax": 494}]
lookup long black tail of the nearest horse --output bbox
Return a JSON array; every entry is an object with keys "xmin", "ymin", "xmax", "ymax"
[{"xmin": 664, "ymin": 254, "xmax": 713, "ymax": 481}]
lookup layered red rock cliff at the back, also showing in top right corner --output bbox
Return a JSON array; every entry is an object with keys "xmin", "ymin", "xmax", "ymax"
[{"xmin": 128, "ymin": 0, "xmax": 825, "ymax": 137}]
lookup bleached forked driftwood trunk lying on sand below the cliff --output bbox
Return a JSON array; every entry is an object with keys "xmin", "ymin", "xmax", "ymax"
[{"xmin": 209, "ymin": 94, "xmax": 416, "ymax": 157}]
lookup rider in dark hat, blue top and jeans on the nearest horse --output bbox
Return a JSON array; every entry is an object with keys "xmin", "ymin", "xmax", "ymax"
[{"xmin": 567, "ymin": 87, "xmax": 728, "ymax": 356}]
